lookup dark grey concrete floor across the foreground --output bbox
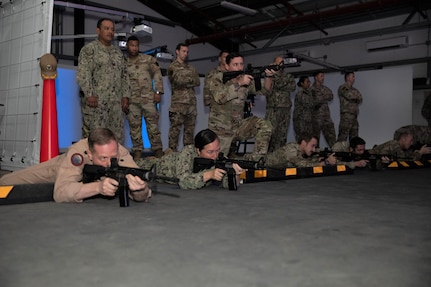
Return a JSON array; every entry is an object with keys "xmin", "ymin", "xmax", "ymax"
[{"xmin": 0, "ymin": 168, "xmax": 431, "ymax": 287}]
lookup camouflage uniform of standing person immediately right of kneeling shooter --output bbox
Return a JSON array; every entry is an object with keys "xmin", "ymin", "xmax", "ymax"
[{"xmin": 265, "ymin": 73, "xmax": 296, "ymax": 151}]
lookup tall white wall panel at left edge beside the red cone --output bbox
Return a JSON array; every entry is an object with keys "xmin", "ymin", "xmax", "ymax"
[{"xmin": 0, "ymin": 0, "xmax": 54, "ymax": 170}]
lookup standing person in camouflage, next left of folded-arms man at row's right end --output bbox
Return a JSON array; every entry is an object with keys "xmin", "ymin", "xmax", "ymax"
[{"xmin": 311, "ymin": 71, "xmax": 336, "ymax": 146}]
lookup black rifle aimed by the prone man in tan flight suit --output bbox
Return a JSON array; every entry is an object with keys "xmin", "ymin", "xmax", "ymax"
[{"xmin": 82, "ymin": 158, "xmax": 179, "ymax": 207}]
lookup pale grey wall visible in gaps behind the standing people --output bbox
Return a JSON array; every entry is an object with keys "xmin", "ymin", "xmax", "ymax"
[{"xmin": 56, "ymin": 66, "xmax": 413, "ymax": 151}]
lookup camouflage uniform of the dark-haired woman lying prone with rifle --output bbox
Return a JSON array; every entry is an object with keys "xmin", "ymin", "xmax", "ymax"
[{"xmin": 136, "ymin": 145, "xmax": 233, "ymax": 189}]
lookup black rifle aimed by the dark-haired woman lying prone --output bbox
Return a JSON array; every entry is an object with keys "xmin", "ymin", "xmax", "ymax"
[{"xmin": 193, "ymin": 153, "xmax": 265, "ymax": 190}]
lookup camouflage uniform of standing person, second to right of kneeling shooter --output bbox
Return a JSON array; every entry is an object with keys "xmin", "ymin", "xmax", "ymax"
[{"xmin": 293, "ymin": 87, "xmax": 314, "ymax": 141}]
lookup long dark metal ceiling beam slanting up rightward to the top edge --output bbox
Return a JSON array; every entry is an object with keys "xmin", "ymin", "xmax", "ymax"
[{"xmin": 186, "ymin": 0, "xmax": 412, "ymax": 45}]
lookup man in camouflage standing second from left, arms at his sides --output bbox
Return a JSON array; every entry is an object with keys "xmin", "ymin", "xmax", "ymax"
[{"xmin": 126, "ymin": 36, "xmax": 163, "ymax": 160}]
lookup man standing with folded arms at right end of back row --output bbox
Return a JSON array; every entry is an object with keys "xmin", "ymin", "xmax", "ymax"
[{"xmin": 338, "ymin": 71, "xmax": 362, "ymax": 141}]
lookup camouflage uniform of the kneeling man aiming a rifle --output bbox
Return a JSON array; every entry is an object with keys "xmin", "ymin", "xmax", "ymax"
[{"xmin": 208, "ymin": 72, "xmax": 272, "ymax": 160}]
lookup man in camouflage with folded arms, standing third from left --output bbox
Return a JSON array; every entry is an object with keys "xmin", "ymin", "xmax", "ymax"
[{"xmin": 168, "ymin": 43, "xmax": 200, "ymax": 151}]
